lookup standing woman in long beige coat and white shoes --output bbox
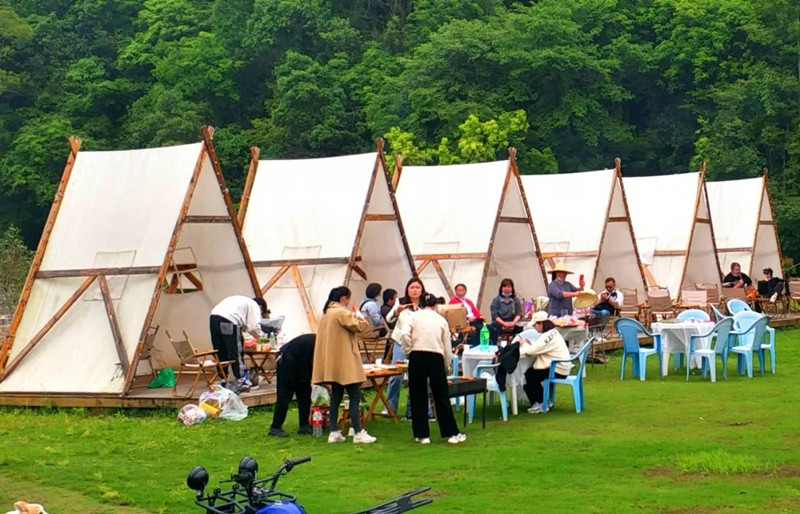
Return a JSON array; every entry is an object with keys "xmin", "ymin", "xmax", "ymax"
[{"xmin": 311, "ymin": 286, "xmax": 376, "ymax": 444}]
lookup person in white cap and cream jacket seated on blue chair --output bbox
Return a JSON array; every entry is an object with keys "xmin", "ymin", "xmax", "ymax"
[{"xmin": 519, "ymin": 311, "xmax": 572, "ymax": 414}]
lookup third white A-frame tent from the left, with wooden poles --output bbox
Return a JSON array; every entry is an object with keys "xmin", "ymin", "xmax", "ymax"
[{"xmin": 395, "ymin": 148, "xmax": 547, "ymax": 318}]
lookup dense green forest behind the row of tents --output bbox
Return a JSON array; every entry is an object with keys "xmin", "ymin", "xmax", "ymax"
[{"xmin": 0, "ymin": 0, "xmax": 800, "ymax": 268}]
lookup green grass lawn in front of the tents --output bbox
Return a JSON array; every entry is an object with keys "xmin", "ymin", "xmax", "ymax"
[{"xmin": 0, "ymin": 330, "xmax": 800, "ymax": 514}]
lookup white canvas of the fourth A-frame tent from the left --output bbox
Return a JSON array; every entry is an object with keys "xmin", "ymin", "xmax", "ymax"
[{"xmin": 522, "ymin": 168, "xmax": 646, "ymax": 298}]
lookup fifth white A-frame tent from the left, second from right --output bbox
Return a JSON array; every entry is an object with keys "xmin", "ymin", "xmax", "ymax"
[{"xmin": 623, "ymin": 165, "xmax": 722, "ymax": 298}]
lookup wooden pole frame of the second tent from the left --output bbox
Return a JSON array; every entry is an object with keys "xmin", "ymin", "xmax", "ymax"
[{"xmin": 238, "ymin": 138, "xmax": 417, "ymax": 332}]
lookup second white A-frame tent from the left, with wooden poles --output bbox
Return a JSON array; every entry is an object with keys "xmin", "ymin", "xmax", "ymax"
[{"xmin": 239, "ymin": 140, "xmax": 414, "ymax": 336}]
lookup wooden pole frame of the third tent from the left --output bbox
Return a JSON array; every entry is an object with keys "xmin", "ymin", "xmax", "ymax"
[{"xmin": 392, "ymin": 146, "xmax": 547, "ymax": 305}]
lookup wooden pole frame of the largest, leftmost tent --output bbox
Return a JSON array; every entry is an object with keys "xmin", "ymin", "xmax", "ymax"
[{"xmin": 0, "ymin": 126, "xmax": 261, "ymax": 397}]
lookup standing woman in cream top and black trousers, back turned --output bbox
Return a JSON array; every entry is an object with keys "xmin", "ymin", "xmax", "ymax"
[{"xmin": 399, "ymin": 293, "xmax": 467, "ymax": 444}]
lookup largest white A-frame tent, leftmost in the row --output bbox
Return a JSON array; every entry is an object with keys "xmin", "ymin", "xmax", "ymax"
[{"xmin": 0, "ymin": 127, "xmax": 258, "ymax": 396}]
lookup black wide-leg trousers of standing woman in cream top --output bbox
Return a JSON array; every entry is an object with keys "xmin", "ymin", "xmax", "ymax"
[{"xmin": 408, "ymin": 352, "xmax": 459, "ymax": 438}]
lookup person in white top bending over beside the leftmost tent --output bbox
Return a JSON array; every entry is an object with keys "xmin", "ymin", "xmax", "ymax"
[{"xmin": 209, "ymin": 295, "xmax": 267, "ymax": 388}]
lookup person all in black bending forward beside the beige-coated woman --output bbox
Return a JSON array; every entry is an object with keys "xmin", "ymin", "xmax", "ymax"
[{"xmin": 268, "ymin": 334, "xmax": 317, "ymax": 437}]
